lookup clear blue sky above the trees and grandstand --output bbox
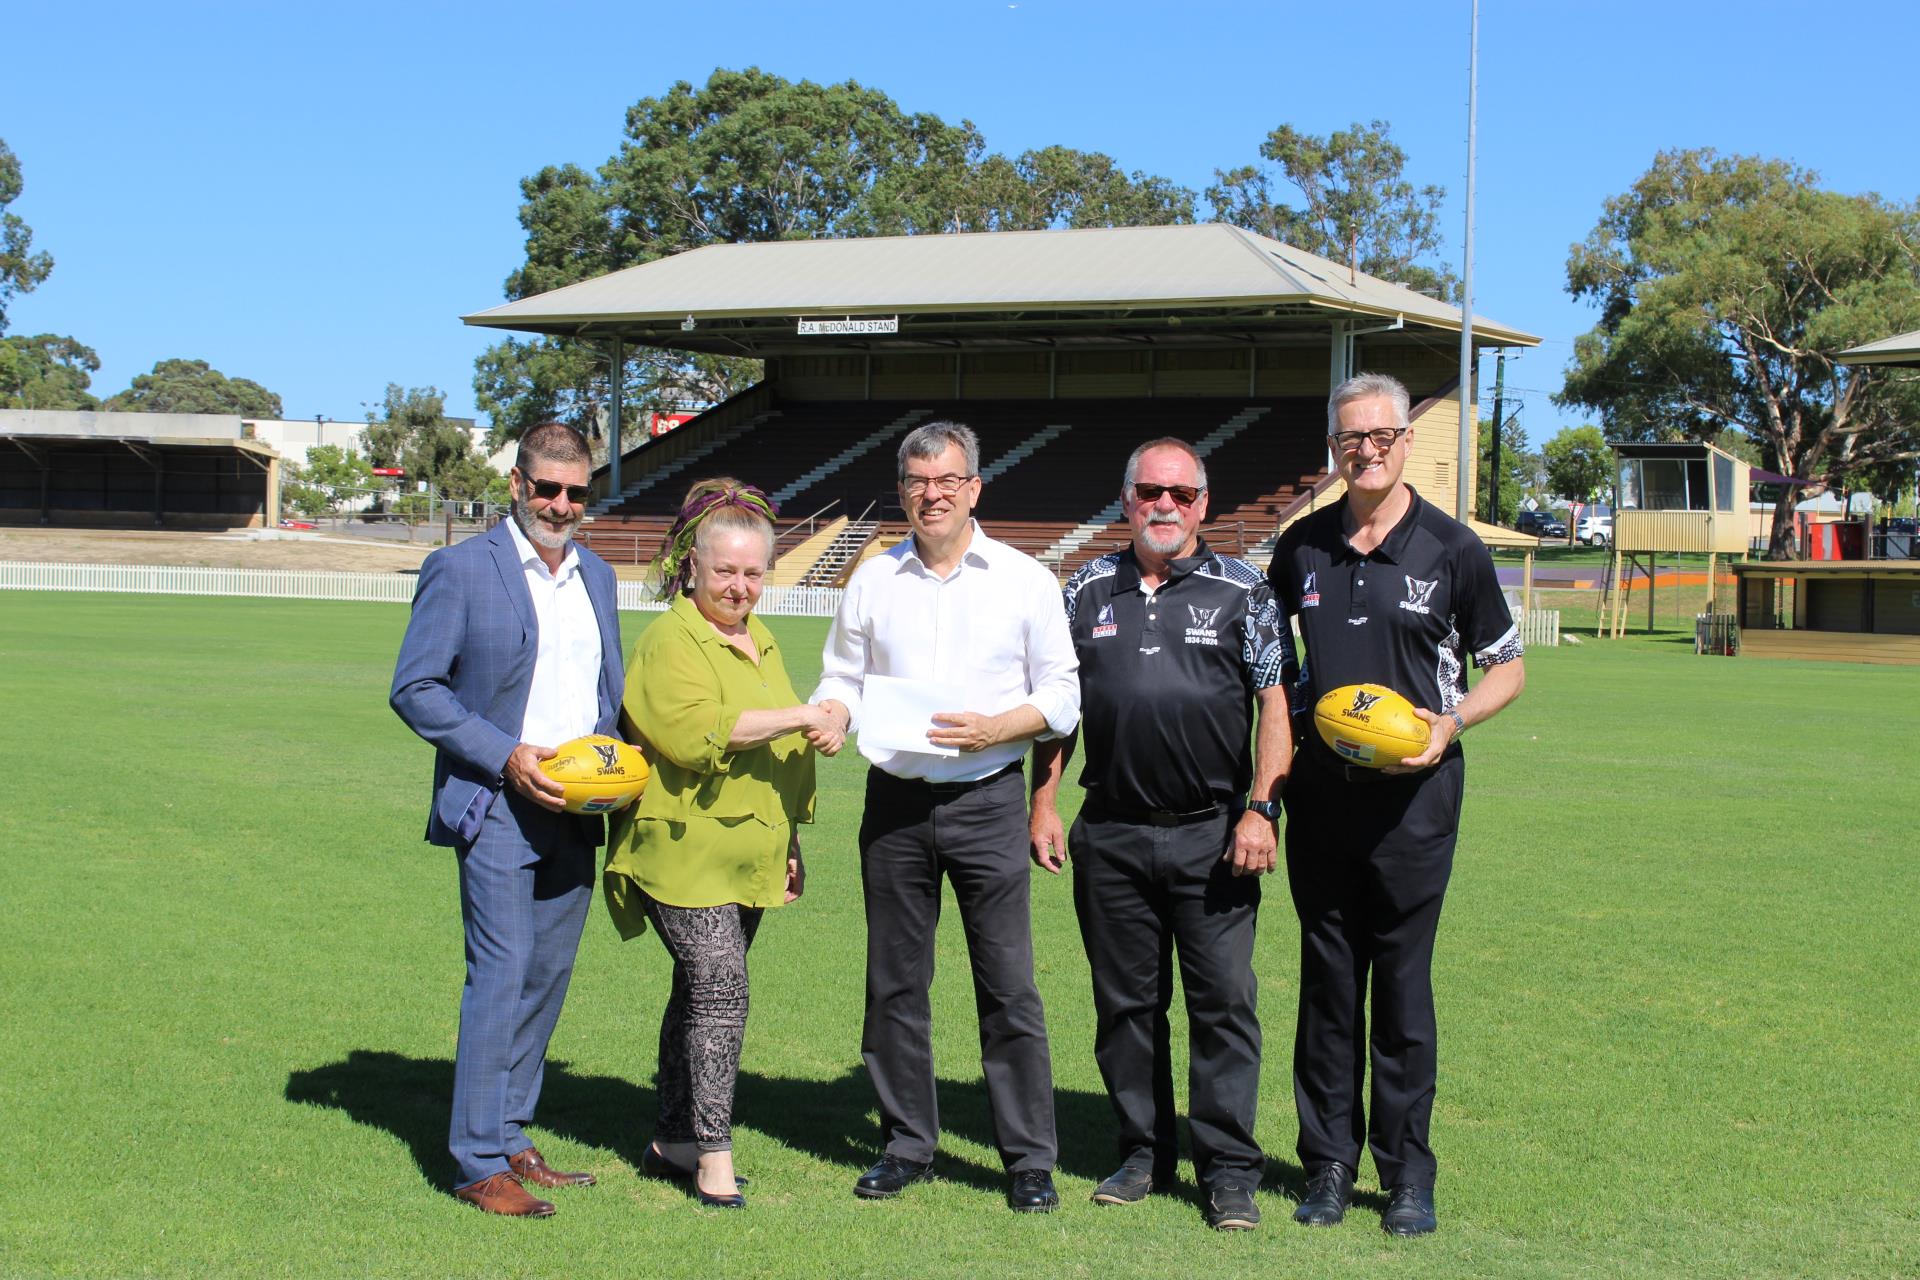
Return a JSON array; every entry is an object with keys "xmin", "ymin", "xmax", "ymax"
[{"xmin": 0, "ymin": 0, "xmax": 1920, "ymax": 443}]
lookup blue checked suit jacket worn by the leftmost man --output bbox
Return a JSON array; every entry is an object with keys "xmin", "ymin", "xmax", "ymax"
[{"xmin": 388, "ymin": 516, "xmax": 626, "ymax": 844}]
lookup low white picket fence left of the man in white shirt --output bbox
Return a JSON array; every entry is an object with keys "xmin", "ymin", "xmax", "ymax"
[{"xmin": 0, "ymin": 560, "xmax": 841, "ymax": 618}]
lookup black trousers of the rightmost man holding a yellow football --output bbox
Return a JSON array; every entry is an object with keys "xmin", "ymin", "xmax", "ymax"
[{"xmin": 1284, "ymin": 745, "xmax": 1465, "ymax": 1186}]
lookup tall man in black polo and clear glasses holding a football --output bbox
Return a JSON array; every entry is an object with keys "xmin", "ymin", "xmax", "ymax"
[{"xmin": 1269, "ymin": 374, "xmax": 1526, "ymax": 1236}]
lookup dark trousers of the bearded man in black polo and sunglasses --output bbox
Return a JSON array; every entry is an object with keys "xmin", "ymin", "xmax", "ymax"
[{"xmin": 1068, "ymin": 798, "xmax": 1265, "ymax": 1186}]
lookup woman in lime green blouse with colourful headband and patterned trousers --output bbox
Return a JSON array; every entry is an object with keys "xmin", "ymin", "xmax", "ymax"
[{"xmin": 605, "ymin": 478, "xmax": 841, "ymax": 1209}]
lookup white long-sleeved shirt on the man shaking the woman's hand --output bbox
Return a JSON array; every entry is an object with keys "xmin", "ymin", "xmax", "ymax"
[{"xmin": 812, "ymin": 522, "xmax": 1079, "ymax": 783}]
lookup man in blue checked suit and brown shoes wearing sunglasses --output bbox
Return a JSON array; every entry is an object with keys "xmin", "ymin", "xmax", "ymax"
[{"xmin": 390, "ymin": 422, "xmax": 624, "ymax": 1217}]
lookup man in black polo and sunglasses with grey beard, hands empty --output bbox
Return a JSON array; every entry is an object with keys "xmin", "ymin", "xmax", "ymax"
[{"xmin": 1031, "ymin": 438, "xmax": 1292, "ymax": 1230}]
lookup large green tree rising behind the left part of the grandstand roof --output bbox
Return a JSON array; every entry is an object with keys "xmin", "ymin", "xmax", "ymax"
[{"xmin": 474, "ymin": 67, "xmax": 1194, "ymax": 443}]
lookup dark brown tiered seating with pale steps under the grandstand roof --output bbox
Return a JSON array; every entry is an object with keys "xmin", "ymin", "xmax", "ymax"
[{"xmin": 584, "ymin": 397, "xmax": 1327, "ymax": 581}]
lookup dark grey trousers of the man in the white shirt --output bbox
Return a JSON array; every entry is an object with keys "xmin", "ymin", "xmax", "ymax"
[{"xmin": 860, "ymin": 770, "xmax": 1056, "ymax": 1171}]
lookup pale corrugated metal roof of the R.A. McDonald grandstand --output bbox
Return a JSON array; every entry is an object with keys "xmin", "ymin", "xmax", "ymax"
[{"xmin": 463, "ymin": 223, "xmax": 1538, "ymax": 345}]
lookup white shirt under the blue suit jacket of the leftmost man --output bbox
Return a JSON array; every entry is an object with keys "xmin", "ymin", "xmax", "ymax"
[{"xmin": 507, "ymin": 514, "xmax": 601, "ymax": 747}]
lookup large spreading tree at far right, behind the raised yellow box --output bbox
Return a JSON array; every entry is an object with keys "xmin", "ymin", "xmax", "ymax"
[{"xmin": 1559, "ymin": 150, "xmax": 1920, "ymax": 555}]
